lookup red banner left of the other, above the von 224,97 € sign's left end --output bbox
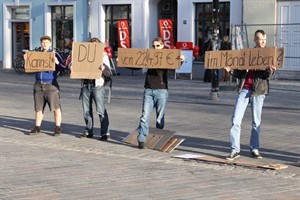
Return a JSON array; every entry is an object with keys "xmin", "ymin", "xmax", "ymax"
[{"xmin": 118, "ymin": 20, "xmax": 130, "ymax": 48}]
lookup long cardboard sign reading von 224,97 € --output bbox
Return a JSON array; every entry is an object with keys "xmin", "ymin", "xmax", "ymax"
[{"xmin": 118, "ymin": 48, "xmax": 181, "ymax": 69}]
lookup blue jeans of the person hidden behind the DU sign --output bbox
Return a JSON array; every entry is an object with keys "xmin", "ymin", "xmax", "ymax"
[{"xmin": 82, "ymin": 84, "xmax": 109, "ymax": 135}]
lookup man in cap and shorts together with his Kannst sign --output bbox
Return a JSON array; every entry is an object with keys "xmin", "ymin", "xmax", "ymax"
[{"xmin": 28, "ymin": 35, "xmax": 65, "ymax": 136}]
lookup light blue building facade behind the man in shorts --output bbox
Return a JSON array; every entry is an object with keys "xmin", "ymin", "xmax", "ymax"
[{"xmin": 0, "ymin": 0, "xmax": 89, "ymax": 68}]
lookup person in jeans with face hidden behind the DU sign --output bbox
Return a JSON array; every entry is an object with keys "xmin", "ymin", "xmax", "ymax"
[{"xmin": 80, "ymin": 38, "xmax": 110, "ymax": 141}]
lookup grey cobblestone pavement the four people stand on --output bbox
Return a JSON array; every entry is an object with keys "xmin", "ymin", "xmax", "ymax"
[{"xmin": 0, "ymin": 70, "xmax": 300, "ymax": 200}]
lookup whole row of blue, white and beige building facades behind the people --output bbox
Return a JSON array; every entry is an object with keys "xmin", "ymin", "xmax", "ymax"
[{"xmin": 0, "ymin": 0, "xmax": 300, "ymax": 78}]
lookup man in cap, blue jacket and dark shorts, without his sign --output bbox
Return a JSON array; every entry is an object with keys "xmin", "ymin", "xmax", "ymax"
[{"xmin": 28, "ymin": 35, "xmax": 65, "ymax": 136}]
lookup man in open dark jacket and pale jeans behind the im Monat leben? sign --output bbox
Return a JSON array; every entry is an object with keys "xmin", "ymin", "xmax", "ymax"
[{"xmin": 225, "ymin": 30, "xmax": 276, "ymax": 161}]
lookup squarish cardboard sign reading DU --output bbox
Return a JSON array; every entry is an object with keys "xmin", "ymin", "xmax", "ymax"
[{"xmin": 70, "ymin": 42, "xmax": 104, "ymax": 79}]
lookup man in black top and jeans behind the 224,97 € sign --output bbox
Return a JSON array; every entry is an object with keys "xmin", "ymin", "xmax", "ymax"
[{"xmin": 137, "ymin": 37, "xmax": 185, "ymax": 149}]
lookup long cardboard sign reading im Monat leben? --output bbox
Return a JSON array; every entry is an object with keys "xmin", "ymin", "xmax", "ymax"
[{"xmin": 204, "ymin": 47, "xmax": 284, "ymax": 69}]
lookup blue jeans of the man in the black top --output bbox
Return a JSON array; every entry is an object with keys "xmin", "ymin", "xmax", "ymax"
[{"xmin": 137, "ymin": 89, "xmax": 169, "ymax": 142}]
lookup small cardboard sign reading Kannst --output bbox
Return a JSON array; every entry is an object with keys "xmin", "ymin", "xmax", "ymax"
[{"xmin": 24, "ymin": 51, "xmax": 55, "ymax": 73}]
